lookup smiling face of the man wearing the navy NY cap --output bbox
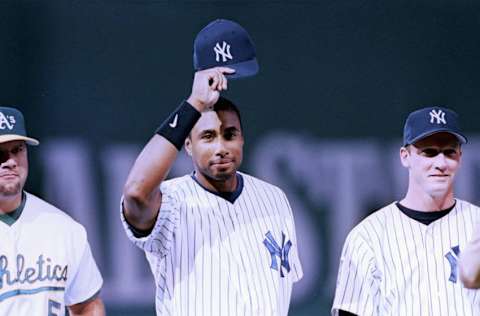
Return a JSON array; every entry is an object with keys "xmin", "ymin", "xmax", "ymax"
[{"xmin": 400, "ymin": 133, "xmax": 462, "ymax": 197}]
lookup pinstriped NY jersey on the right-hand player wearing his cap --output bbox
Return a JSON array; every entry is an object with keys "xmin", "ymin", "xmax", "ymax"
[{"xmin": 332, "ymin": 199, "xmax": 480, "ymax": 316}]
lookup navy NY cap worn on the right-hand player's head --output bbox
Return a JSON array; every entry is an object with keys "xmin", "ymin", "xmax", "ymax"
[{"xmin": 403, "ymin": 106, "xmax": 467, "ymax": 146}]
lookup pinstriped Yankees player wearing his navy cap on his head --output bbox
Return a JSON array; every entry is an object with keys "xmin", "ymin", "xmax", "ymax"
[{"xmin": 332, "ymin": 107, "xmax": 480, "ymax": 316}]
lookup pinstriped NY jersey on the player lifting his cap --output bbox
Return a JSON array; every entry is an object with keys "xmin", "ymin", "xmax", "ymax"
[{"xmin": 121, "ymin": 173, "xmax": 303, "ymax": 316}]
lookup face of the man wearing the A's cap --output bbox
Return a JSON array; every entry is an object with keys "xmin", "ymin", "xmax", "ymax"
[{"xmin": 0, "ymin": 140, "xmax": 28, "ymax": 197}]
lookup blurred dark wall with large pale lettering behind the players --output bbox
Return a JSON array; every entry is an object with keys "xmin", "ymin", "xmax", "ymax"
[{"xmin": 0, "ymin": 0, "xmax": 480, "ymax": 316}]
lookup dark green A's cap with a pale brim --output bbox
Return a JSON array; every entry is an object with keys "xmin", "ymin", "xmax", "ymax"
[{"xmin": 0, "ymin": 107, "xmax": 39, "ymax": 146}]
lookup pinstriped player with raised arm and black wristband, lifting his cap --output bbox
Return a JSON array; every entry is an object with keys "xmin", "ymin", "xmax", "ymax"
[{"xmin": 121, "ymin": 21, "xmax": 303, "ymax": 316}]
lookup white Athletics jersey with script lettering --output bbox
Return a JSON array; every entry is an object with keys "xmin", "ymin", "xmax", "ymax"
[{"xmin": 0, "ymin": 193, "xmax": 102, "ymax": 316}]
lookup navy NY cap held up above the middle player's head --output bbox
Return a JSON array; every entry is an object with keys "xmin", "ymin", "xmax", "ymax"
[{"xmin": 193, "ymin": 19, "xmax": 259, "ymax": 79}]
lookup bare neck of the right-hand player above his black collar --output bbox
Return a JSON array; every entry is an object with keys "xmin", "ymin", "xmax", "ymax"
[{"xmin": 400, "ymin": 188, "xmax": 455, "ymax": 212}]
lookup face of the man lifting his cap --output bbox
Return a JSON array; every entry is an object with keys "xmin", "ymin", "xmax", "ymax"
[{"xmin": 185, "ymin": 111, "xmax": 243, "ymax": 181}]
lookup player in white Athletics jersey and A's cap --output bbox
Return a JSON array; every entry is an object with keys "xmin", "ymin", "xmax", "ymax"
[{"xmin": 0, "ymin": 107, "xmax": 105, "ymax": 316}]
